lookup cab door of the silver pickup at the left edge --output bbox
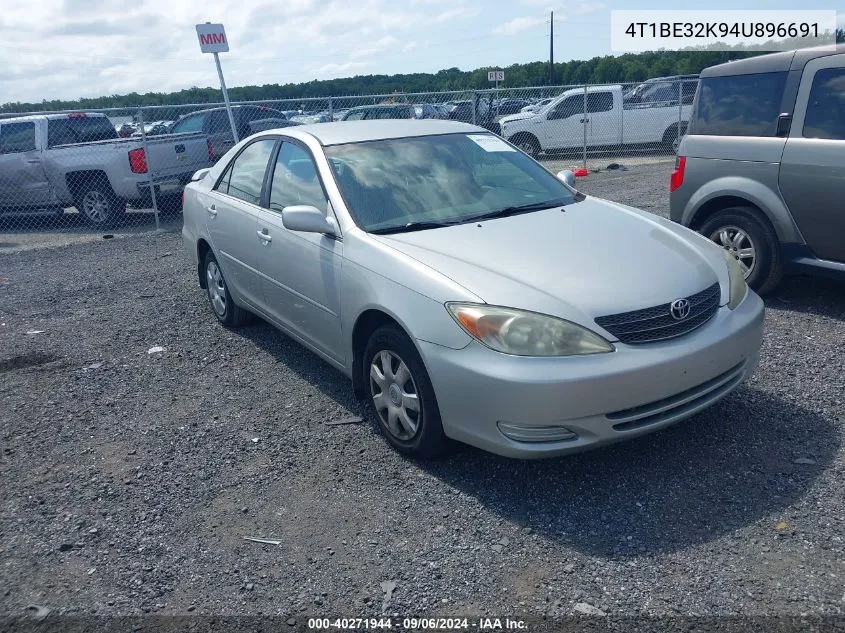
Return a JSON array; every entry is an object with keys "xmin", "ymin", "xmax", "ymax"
[{"xmin": 0, "ymin": 121, "xmax": 52, "ymax": 207}]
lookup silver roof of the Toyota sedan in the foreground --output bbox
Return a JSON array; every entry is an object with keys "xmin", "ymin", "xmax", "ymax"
[{"xmin": 278, "ymin": 119, "xmax": 487, "ymax": 146}]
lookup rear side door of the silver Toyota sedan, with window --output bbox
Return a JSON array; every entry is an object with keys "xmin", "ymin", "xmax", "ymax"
[{"xmin": 202, "ymin": 138, "xmax": 277, "ymax": 307}]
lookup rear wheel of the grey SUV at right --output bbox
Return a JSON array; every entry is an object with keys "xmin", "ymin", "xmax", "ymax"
[{"xmin": 699, "ymin": 207, "xmax": 783, "ymax": 294}]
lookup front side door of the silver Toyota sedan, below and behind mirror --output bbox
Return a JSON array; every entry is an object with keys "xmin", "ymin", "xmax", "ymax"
[{"xmin": 258, "ymin": 141, "xmax": 344, "ymax": 362}]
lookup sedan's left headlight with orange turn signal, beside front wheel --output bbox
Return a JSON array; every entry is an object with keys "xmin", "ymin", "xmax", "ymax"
[{"xmin": 446, "ymin": 303, "xmax": 613, "ymax": 356}]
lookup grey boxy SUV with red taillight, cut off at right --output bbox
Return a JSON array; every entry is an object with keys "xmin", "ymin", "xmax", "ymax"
[{"xmin": 669, "ymin": 45, "xmax": 845, "ymax": 293}]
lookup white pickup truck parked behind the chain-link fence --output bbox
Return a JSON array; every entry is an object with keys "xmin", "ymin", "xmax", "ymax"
[{"xmin": 499, "ymin": 86, "xmax": 691, "ymax": 157}]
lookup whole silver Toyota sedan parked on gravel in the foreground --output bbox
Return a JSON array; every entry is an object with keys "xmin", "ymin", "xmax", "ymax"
[{"xmin": 183, "ymin": 120, "xmax": 763, "ymax": 457}]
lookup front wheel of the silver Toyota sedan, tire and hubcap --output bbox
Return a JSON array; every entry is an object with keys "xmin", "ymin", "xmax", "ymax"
[{"xmin": 362, "ymin": 325, "xmax": 450, "ymax": 458}]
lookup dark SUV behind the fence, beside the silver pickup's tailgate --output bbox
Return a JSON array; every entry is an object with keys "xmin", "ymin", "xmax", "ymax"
[{"xmin": 170, "ymin": 105, "xmax": 292, "ymax": 158}]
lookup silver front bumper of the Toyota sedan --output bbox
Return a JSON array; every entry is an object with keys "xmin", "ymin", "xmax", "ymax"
[{"xmin": 418, "ymin": 291, "xmax": 763, "ymax": 458}]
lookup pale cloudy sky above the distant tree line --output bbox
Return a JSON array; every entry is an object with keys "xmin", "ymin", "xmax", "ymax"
[{"xmin": 0, "ymin": 0, "xmax": 845, "ymax": 103}]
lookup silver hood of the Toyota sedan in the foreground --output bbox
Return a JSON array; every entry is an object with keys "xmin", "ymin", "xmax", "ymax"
[{"xmin": 372, "ymin": 197, "xmax": 727, "ymax": 324}]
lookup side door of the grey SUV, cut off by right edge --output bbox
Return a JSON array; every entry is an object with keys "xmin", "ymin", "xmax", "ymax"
[{"xmin": 779, "ymin": 54, "xmax": 845, "ymax": 262}]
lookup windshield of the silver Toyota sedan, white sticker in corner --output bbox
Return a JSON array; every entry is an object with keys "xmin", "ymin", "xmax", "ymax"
[{"xmin": 325, "ymin": 133, "xmax": 576, "ymax": 233}]
